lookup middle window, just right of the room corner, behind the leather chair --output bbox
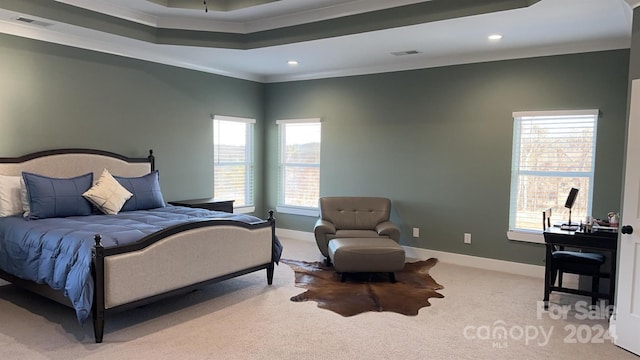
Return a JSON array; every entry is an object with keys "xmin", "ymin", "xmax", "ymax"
[{"xmin": 276, "ymin": 119, "xmax": 320, "ymax": 216}]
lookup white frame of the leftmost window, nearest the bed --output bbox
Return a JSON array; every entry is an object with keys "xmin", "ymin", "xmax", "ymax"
[{"xmin": 212, "ymin": 115, "xmax": 256, "ymax": 213}]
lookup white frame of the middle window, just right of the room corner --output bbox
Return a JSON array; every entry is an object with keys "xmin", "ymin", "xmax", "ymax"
[{"xmin": 276, "ymin": 118, "xmax": 322, "ymax": 217}]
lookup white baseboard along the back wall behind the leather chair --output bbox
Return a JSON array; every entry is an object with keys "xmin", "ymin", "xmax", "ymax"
[{"xmin": 276, "ymin": 229, "xmax": 544, "ymax": 279}]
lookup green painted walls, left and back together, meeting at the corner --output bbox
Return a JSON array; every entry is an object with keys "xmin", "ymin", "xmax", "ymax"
[{"xmin": 0, "ymin": 31, "xmax": 629, "ymax": 264}]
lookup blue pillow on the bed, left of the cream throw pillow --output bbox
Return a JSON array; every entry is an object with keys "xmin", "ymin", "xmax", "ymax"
[{"xmin": 22, "ymin": 172, "xmax": 93, "ymax": 219}]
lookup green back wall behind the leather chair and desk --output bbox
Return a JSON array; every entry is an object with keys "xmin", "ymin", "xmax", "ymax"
[{"xmin": 266, "ymin": 50, "xmax": 629, "ymax": 264}]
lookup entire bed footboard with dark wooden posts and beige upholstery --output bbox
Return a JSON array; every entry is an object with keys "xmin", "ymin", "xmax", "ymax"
[{"xmin": 92, "ymin": 215, "xmax": 279, "ymax": 342}]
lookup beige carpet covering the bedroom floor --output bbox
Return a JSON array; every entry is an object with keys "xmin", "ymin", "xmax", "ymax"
[{"xmin": 0, "ymin": 239, "xmax": 637, "ymax": 360}]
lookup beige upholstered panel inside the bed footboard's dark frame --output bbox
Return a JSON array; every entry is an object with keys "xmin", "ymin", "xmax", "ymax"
[{"xmin": 104, "ymin": 226, "xmax": 272, "ymax": 309}]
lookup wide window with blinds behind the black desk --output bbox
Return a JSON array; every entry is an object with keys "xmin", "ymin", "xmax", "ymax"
[{"xmin": 509, "ymin": 110, "xmax": 598, "ymax": 240}]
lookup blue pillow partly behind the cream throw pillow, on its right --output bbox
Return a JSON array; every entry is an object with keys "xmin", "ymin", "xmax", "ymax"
[{"xmin": 113, "ymin": 170, "xmax": 165, "ymax": 212}]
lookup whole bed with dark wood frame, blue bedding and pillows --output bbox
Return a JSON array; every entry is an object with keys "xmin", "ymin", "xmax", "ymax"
[{"xmin": 0, "ymin": 149, "xmax": 282, "ymax": 343}]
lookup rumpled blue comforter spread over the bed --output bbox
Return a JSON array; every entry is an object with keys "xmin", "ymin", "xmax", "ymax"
[{"xmin": 0, "ymin": 206, "xmax": 281, "ymax": 323}]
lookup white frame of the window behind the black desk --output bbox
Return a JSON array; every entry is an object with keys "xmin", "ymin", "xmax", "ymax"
[{"xmin": 507, "ymin": 109, "xmax": 599, "ymax": 244}]
